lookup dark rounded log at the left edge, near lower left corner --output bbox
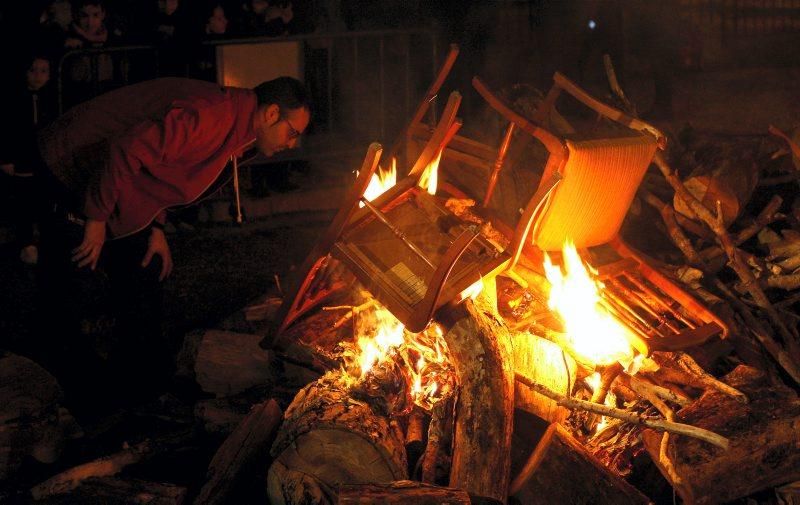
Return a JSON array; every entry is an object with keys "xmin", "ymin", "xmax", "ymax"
[{"xmin": 0, "ymin": 354, "xmax": 82, "ymax": 482}]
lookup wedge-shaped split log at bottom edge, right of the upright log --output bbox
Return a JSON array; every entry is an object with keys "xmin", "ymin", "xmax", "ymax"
[{"xmin": 510, "ymin": 423, "xmax": 650, "ymax": 505}]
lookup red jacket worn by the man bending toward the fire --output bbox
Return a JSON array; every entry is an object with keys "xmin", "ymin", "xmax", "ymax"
[{"xmin": 39, "ymin": 78, "xmax": 258, "ymax": 237}]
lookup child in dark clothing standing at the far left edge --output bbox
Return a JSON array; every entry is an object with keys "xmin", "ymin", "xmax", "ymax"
[{"xmin": 0, "ymin": 54, "xmax": 57, "ymax": 264}]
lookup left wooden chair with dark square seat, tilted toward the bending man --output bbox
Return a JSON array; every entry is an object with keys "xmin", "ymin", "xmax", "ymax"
[{"xmin": 262, "ymin": 92, "xmax": 506, "ymax": 347}]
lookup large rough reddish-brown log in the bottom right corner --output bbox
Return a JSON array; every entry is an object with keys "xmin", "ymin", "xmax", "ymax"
[{"xmin": 643, "ymin": 365, "xmax": 800, "ymax": 503}]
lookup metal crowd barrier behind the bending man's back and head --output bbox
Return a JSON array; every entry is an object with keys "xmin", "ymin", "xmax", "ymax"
[{"xmin": 57, "ymin": 29, "xmax": 439, "ymax": 159}]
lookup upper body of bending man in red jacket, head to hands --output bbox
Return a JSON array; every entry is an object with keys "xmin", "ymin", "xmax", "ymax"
[{"xmin": 39, "ymin": 77, "xmax": 310, "ymax": 279}]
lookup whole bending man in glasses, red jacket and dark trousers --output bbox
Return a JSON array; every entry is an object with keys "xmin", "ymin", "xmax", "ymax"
[{"xmin": 39, "ymin": 77, "xmax": 310, "ymax": 410}]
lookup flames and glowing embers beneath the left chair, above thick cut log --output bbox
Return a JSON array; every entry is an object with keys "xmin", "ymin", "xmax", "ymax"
[{"xmin": 344, "ymin": 306, "xmax": 456, "ymax": 410}]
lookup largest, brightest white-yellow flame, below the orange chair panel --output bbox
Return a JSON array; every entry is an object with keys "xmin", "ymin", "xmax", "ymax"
[{"xmin": 544, "ymin": 241, "xmax": 633, "ymax": 365}]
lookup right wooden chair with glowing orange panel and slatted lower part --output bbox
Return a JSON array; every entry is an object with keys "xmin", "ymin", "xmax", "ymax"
[{"xmin": 473, "ymin": 73, "xmax": 727, "ymax": 354}]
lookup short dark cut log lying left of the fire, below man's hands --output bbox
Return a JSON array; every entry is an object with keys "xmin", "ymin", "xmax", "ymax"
[{"xmin": 194, "ymin": 330, "xmax": 274, "ymax": 396}]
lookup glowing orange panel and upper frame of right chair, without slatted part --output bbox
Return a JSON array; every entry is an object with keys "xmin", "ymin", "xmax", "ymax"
[{"xmin": 473, "ymin": 73, "xmax": 666, "ymax": 255}]
